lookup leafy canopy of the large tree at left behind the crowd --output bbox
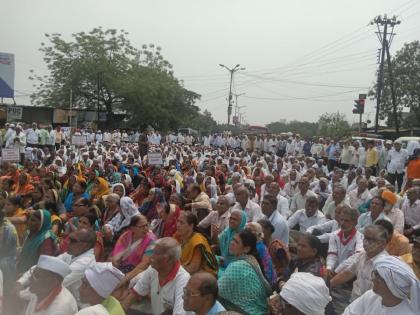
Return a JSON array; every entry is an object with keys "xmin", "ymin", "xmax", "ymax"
[{"xmin": 30, "ymin": 27, "xmax": 208, "ymax": 131}]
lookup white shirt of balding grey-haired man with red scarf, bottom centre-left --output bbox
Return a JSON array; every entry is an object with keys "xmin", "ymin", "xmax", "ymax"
[{"xmin": 133, "ymin": 266, "xmax": 190, "ymax": 315}]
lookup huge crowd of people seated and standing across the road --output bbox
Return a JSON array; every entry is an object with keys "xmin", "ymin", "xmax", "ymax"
[{"xmin": 0, "ymin": 123, "xmax": 420, "ymax": 315}]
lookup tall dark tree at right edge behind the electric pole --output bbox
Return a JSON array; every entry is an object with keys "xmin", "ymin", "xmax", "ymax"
[{"xmin": 369, "ymin": 41, "xmax": 420, "ymax": 125}]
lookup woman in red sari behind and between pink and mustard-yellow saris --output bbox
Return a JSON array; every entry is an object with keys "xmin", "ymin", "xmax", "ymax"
[{"xmin": 152, "ymin": 203, "xmax": 181, "ymax": 238}]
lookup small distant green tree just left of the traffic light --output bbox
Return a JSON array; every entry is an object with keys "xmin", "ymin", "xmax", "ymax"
[{"xmin": 318, "ymin": 112, "xmax": 351, "ymax": 138}]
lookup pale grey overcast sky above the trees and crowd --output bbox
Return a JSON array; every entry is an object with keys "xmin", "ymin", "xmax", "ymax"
[{"xmin": 0, "ymin": 0, "xmax": 420, "ymax": 124}]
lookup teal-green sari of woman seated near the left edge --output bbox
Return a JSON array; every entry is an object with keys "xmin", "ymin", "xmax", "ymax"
[{"xmin": 17, "ymin": 210, "xmax": 57, "ymax": 274}]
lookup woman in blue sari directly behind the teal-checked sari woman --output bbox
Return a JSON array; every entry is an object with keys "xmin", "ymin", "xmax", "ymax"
[{"xmin": 245, "ymin": 222, "xmax": 277, "ymax": 287}]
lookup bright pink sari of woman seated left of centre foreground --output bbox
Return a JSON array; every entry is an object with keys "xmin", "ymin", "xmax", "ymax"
[{"xmin": 111, "ymin": 230, "xmax": 156, "ymax": 271}]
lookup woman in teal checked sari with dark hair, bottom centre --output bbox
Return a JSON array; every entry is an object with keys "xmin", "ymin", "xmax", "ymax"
[{"xmin": 218, "ymin": 230, "xmax": 272, "ymax": 315}]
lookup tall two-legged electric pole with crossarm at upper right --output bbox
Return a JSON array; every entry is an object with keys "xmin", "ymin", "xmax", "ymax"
[{"xmin": 370, "ymin": 14, "xmax": 401, "ymax": 134}]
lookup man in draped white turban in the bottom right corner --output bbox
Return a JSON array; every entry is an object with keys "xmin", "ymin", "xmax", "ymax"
[{"xmin": 344, "ymin": 256, "xmax": 420, "ymax": 315}]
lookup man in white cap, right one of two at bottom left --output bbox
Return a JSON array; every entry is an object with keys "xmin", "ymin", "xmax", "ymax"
[{"xmin": 76, "ymin": 263, "xmax": 124, "ymax": 315}]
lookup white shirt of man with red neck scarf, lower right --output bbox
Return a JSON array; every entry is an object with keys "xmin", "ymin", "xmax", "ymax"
[{"xmin": 327, "ymin": 230, "xmax": 363, "ymax": 270}]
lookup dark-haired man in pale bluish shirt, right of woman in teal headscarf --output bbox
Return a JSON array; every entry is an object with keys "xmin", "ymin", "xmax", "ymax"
[{"xmin": 261, "ymin": 195, "xmax": 289, "ymax": 245}]
